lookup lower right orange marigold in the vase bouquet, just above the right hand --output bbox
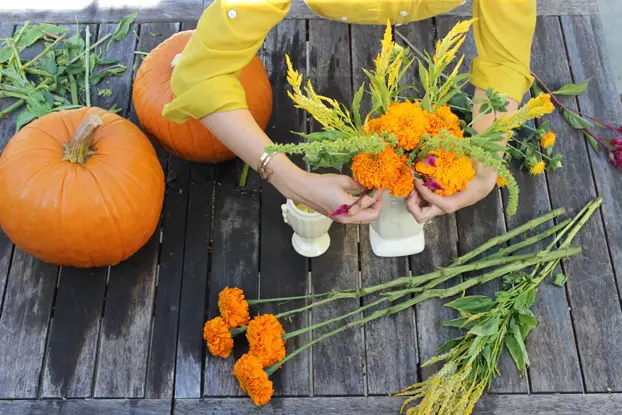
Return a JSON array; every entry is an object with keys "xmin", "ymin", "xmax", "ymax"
[{"xmin": 415, "ymin": 148, "xmax": 475, "ymax": 196}]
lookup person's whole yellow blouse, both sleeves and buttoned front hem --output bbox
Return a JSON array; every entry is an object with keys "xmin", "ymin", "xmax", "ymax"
[{"xmin": 163, "ymin": 0, "xmax": 536, "ymax": 123}]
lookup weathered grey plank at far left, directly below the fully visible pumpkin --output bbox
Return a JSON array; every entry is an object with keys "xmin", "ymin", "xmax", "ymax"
[{"xmin": 0, "ymin": 249, "xmax": 58, "ymax": 399}]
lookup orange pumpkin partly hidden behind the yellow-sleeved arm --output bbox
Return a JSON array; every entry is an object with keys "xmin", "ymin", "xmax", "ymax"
[{"xmin": 133, "ymin": 31, "xmax": 272, "ymax": 163}]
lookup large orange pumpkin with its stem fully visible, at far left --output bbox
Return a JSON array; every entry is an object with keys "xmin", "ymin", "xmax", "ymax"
[{"xmin": 0, "ymin": 108, "xmax": 164, "ymax": 267}]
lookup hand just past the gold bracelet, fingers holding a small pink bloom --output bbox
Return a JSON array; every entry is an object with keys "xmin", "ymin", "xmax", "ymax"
[{"xmin": 270, "ymin": 156, "xmax": 383, "ymax": 224}]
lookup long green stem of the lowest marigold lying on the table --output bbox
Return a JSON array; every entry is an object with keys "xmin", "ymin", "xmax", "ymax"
[{"xmin": 265, "ymin": 244, "xmax": 581, "ymax": 375}]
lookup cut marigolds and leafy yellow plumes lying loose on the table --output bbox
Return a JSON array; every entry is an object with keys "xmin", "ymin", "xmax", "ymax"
[{"xmin": 203, "ymin": 199, "xmax": 602, "ymax": 415}]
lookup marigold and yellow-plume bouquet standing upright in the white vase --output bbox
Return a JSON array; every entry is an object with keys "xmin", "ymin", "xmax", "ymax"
[{"xmin": 267, "ymin": 20, "xmax": 554, "ymax": 214}]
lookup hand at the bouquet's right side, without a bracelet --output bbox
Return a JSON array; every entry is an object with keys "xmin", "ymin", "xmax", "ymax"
[{"xmin": 406, "ymin": 162, "xmax": 497, "ymax": 223}]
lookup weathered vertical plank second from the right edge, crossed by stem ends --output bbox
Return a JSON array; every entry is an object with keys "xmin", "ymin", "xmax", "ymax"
[{"xmin": 520, "ymin": 18, "xmax": 591, "ymax": 392}]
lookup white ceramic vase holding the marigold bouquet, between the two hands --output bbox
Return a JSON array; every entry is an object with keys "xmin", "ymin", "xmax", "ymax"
[{"xmin": 369, "ymin": 192, "xmax": 425, "ymax": 257}]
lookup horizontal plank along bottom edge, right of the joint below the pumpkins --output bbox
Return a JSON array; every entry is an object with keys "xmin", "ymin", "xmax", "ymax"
[{"xmin": 175, "ymin": 394, "xmax": 622, "ymax": 415}]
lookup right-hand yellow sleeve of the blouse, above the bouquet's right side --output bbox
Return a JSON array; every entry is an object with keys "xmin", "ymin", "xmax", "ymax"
[{"xmin": 471, "ymin": 0, "xmax": 536, "ymax": 102}]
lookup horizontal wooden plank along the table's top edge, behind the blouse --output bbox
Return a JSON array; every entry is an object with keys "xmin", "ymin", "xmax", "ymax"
[{"xmin": 0, "ymin": 0, "xmax": 598, "ymax": 24}]
